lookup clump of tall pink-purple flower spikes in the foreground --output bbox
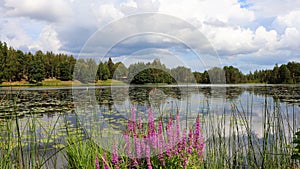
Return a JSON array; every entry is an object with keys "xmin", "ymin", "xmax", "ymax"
[{"xmin": 92, "ymin": 106, "xmax": 205, "ymax": 169}]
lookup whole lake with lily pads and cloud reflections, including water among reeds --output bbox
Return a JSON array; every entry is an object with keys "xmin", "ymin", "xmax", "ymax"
[{"xmin": 0, "ymin": 84, "xmax": 300, "ymax": 168}]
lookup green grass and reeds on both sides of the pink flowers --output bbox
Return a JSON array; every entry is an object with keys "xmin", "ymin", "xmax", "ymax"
[{"xmin": 0, "ymin": 92, "xmax": 299, "ymax": 169}]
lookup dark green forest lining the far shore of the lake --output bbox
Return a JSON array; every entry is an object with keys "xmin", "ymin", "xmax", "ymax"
[{"xmin": 0, "ymin": 41, "xmax": 300, "ymax": 84}]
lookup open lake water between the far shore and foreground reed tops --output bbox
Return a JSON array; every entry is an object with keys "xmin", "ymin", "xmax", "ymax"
[{"xmin": 0, "ymin": 85, "xmax": 300, "ymax": 134}]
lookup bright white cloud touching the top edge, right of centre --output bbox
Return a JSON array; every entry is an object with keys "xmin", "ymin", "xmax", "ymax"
[{"xmin": 160, "ymin": 0, "xmax": 254, "ymax": 24}]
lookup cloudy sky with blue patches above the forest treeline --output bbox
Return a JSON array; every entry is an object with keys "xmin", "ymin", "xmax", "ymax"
[{"xmin": 0, "ymin": 0, "xmax": 300, "ymax": 73}]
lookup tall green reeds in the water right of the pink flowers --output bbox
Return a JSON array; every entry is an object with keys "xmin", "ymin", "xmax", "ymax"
[{"xmin": 203, "ymin": 95, "xmax": 295, "ymax": 168}]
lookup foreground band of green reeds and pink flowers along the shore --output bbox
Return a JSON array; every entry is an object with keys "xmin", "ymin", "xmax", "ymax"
[{"xmin": 0, "ymin": 101, "xmax": 299, "ymax": 169}]
